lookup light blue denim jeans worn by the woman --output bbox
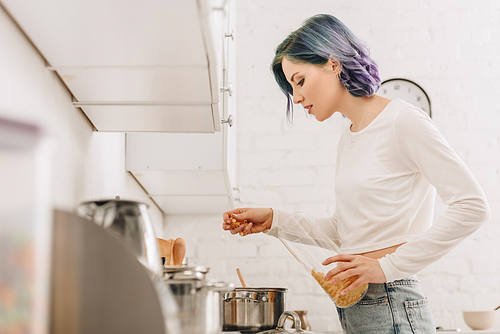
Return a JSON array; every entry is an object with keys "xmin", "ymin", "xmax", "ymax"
[{"xmin": 337, "ymin": 276, "xmax": 436, "ymax": 334}]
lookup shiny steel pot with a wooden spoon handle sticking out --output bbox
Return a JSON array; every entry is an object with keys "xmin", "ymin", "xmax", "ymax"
[{"xmin": 222, "ymin": 287, "xmax": 288, "ymax": 332}]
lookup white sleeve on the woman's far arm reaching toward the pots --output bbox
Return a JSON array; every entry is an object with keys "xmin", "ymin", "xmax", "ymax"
[{"xmin": 264, "ymin": 208, "xmax": 340, "ymax": 253}]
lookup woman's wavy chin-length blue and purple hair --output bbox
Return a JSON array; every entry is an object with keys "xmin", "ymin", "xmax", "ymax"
[{"xmin": 271, "ymin": 14, "xmax": 380, "ymax": 121}]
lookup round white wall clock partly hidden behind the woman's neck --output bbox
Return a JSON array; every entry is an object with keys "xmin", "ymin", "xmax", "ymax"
[{"xmin": 379, "ymin": 78, "xmax": 432, "ymax": 117}]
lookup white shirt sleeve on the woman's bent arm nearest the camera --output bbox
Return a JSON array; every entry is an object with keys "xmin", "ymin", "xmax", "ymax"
[{"xmin": 378, "ymin": 107, "xmax": 490, "ymax": 282}]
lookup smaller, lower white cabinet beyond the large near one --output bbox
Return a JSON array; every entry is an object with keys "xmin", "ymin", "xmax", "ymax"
[{"xmin": 126, "ymin": 127, "xmax": 235, "ymax": 214}]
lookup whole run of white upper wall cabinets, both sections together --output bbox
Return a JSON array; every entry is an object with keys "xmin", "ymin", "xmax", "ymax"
[{"xmin": 0, "ymin": 0, "xmax": 237, "ymax": 214}]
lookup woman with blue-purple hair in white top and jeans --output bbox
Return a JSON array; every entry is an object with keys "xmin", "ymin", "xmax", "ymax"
[{"xmin": 223, "ymin": 15, "xmax": 489, "ymax": 333}]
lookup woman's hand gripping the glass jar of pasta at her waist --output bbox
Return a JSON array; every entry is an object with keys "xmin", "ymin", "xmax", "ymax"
[{"xmin": 322, "ymin": 254, "xmax": 386, "ymax": 294}]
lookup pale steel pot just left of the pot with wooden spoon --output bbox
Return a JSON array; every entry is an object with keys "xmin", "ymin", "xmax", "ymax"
[{"xmin": 164, "ymin": 278, "xmax": 234, "ymax": 334}]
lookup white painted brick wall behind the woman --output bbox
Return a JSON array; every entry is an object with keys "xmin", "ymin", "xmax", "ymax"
[{"xmin": 164, "ymin": 0, "xmax": 500, "ymax": 331}]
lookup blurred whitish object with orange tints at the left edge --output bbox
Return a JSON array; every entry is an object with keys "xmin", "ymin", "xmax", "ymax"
[{"xmin": 0, "ymin": 117, "xmax": 53, "ymax": 334}]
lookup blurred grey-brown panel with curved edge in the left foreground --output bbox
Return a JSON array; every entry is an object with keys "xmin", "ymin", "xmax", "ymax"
[{"xmin": 50, "ymin": 211, "xmax": 166, "ymax": 334}]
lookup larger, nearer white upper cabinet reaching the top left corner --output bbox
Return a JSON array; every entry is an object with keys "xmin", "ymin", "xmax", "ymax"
[{"xmin": 0, "ymin": 0, "xmax": 222, "ymax": 133}]
